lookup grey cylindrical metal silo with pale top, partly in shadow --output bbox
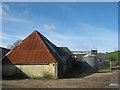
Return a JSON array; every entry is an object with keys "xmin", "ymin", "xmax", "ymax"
[{"xmin": 83, "ymin": 54, "xmax": 97, "ymax": 72}]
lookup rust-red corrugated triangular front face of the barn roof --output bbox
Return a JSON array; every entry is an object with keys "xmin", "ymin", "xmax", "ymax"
[{"xmin": 4, "ymin": 30, "xmax": 57, "ymax": 63}]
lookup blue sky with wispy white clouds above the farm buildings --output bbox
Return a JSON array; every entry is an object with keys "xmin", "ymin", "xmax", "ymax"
[{"xmin": 0, "ymin": 2, "xmax": 118, "ymax": 52}]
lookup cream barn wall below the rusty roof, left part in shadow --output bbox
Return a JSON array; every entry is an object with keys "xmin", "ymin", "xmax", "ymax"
[{"xmin": 2, "ymin": 64, "xmax": 56, "ymax": 78}]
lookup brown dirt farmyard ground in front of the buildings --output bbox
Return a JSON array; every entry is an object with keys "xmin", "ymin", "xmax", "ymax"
[{"xmin": 2, "ymin": 70, "xmax": 120, "ymax": 88}]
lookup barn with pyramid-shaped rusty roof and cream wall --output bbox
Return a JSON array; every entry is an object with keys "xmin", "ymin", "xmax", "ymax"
[{"xmin": 2, "ymin": 30, "xmax": 74, "ymax": 78}]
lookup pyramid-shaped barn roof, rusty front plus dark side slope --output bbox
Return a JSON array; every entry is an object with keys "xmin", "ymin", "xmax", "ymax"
[{"xmin": 2, "ymin": 31, "xmax": 63, "ymax": 64}]
